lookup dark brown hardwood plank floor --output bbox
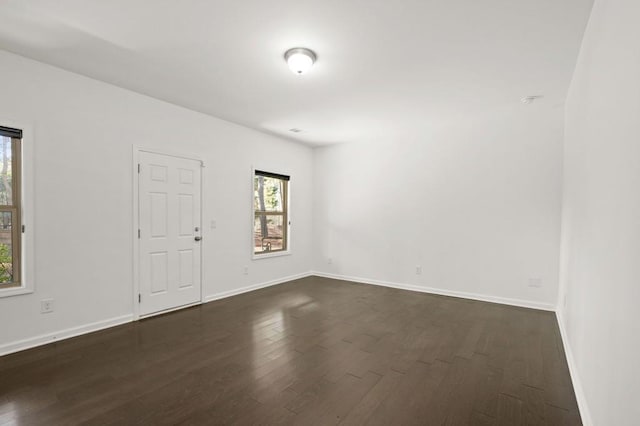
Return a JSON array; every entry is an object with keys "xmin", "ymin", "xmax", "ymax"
[{"xmin": 0, "ymin": 277, "xmax": 580, "ymax": 425}]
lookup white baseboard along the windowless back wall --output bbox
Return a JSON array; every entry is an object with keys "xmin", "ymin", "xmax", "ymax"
[{"xmin": 311, "ymin": 271, "xmax": 555, "ymax": 311}]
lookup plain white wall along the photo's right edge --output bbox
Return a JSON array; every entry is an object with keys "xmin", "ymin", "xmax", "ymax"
[{"xmin": 559, "ymin": 0, "xmax": 640, "ymax": 426}]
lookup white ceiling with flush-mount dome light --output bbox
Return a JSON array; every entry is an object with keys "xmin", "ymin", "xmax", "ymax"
[{"xmin": 0, "ymin": 0, "xmax": 593, "ymax": 145}]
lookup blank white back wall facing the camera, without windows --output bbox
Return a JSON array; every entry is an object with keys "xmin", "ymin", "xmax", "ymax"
[{"xmin": 314, "ymin": 101, "xmax": 563, "ymax": 308}]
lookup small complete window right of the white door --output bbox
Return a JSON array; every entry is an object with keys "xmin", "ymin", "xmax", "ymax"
[{"xmin": 253, "ymin": 170, "xmax": 289, "ymax": 255}]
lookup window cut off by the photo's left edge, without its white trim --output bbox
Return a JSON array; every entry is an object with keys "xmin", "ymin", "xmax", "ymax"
[{"xmin": 0, "ymin": 127, "xmax": 22, "ymax": 289}]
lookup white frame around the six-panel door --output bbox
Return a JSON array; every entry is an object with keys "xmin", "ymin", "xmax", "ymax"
[{"xmin": 131, "ymin": 145, "xmax": 205, "ymax": 321}]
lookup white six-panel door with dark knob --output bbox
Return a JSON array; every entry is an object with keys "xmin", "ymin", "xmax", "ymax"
[{"xmin": 138, "ymin": 151, "xmax": 202, "ymax": 316}]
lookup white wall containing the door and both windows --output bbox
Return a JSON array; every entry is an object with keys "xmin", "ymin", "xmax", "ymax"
[{"xmin": 0, "ymin": 51, "xmax": 313, "ymax": 352}]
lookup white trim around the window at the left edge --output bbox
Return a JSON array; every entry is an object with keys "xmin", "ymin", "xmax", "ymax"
[{"xmin": 0, "ymin": 118, "xmax": 36, "ymax": 298}]
